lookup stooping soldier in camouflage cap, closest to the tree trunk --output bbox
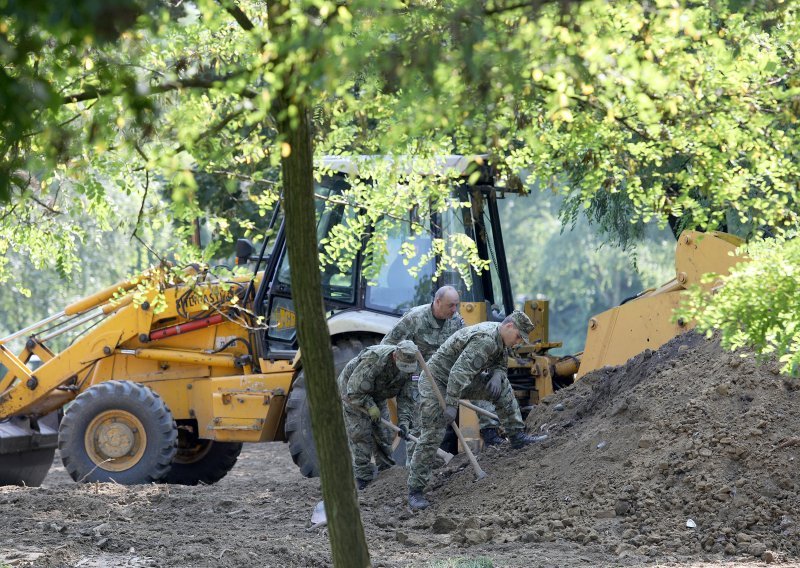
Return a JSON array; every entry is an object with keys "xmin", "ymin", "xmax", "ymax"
[{"xmin": 338, "ymin": 341, "xmax": 419, "ymax": 489}]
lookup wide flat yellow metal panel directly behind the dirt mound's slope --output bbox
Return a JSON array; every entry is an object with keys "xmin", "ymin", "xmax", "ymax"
[{"xmin": 578, "ymin": 291, "xmax": 691, "ymax": 378}]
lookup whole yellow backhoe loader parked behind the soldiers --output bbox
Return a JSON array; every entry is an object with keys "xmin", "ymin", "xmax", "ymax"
[{"xmin": 0, "ymin": 156, "xmax": 752, "ymax": 486}]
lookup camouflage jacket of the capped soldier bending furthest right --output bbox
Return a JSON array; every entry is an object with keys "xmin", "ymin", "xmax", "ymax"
[{"xmin": 419, "ymin": 322, "xmax": 508, "ymax": 406}]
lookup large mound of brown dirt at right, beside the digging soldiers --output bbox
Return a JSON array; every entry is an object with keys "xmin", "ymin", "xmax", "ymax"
[{"xmin": 363, "ymin": 333, "xmax": 800, "ymax": 563}]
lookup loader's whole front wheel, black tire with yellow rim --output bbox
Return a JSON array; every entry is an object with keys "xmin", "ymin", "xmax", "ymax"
[{"xmin": 58, "ymin": 381, "xmax": 178, "ymax": 485}]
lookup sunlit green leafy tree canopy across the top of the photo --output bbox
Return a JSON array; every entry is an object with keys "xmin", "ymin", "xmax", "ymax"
[{"xmin": 0, "ymin": 0, "xmax": 800, "ymax": 364}]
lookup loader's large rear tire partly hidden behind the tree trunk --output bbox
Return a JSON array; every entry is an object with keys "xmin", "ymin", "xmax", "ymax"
[{"xmin": 284, "ymin": 335, "xmax": 380, "ymax": 477}]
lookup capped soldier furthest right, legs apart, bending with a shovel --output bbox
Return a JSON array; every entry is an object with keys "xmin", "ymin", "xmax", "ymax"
[{"xmin": 408, "ymin": 311, "xmax": 539, "ymax": 509}]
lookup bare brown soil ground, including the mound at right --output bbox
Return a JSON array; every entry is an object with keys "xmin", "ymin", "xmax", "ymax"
[{"xmin": 0, "ymin": 334, "xmax": 800, "ymax": 568}]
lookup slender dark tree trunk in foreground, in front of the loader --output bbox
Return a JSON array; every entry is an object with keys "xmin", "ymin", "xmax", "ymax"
[{"xmin": 278, "ymin": 102, "xmax": 370, "ymax": 568}]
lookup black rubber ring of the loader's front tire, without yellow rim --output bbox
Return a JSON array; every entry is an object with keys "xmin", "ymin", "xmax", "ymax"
[{"xmin": 58, "ymin": 381, "xmax": 178, "ymax": 485}]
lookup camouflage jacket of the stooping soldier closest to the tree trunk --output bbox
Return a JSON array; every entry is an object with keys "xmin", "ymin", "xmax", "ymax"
[{"xmin": 338, "ymin": 345, "xmax": 414, "ymax": 426}]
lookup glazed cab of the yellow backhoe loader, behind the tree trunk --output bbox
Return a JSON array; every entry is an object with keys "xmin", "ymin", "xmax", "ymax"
[{"xmin": 247, "ymin": 156, "xmax": 513, "ymax": 367}]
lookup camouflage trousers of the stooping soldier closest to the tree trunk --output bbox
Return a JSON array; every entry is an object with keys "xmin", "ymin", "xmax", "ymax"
[{"xmin": 343, "ymin": 400, "xmax": 394, "ymax": 480}]
